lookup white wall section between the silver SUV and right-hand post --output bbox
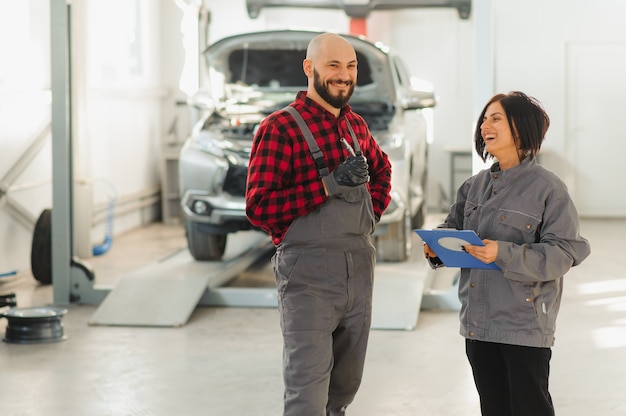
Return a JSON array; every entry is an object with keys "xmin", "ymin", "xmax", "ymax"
[{"xmin": 369, "ymin": 8, "xmax": 474, "ymax": 211}]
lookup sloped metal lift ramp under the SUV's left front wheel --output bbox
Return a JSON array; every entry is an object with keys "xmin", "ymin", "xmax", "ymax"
[{"xmin": 89, "ymin": 233, "xmax": 273, "ymax": 327}]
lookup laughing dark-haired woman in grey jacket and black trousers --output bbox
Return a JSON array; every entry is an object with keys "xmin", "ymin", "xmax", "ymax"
[{"xmin": 424, "ymin": 91, "xmax": 590, "ymax": 416}]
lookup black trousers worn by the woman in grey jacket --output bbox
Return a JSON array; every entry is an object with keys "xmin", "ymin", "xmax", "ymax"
[{"xmin": 465, "ymin": 340, "xmax": 554, "ymax": 416}]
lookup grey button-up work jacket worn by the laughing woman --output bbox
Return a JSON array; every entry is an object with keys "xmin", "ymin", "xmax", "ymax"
[{"xmin": 439, "ymin": 158, "xmax": 590, "ymax": 347}]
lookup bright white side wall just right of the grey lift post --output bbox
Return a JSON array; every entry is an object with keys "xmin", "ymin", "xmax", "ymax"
[{"xmin": 78, "ymin": 0, "xmax": 170, "ymax": 239}]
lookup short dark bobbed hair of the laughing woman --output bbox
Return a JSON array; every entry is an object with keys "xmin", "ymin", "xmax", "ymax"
[{"xmin": 474, "ymin": 91, "xmax": 550, "ymax": 162}]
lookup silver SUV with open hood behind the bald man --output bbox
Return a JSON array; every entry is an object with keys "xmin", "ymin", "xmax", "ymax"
[{"xmin": 179, "ymin": 30, "xmax": 435, "ymax": 261}]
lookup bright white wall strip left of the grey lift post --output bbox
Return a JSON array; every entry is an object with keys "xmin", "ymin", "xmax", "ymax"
[{"xmin": 0, "ymin": 0, "xmax": 52, "ymax": 274}]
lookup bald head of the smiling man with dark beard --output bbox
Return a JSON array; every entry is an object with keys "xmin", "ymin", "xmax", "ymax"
[{"xmin": 303, "ymin": 33, "xmax": 357, "ymax": 115}]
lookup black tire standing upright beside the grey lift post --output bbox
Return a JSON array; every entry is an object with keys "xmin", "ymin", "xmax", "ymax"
[{"xmin": 30, "ymin": 209, "xmax": 52, "ymax": 285}]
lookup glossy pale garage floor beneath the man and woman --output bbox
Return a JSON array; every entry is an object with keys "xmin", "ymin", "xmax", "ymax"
[{"xmin": 0, "ymin": 216, "xmax": 626, "ymax": 416}]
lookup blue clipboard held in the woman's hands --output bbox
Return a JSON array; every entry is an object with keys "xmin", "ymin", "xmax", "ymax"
[{"xmin": 414, "ymin": 228, "xmax": 500, "ymax": 270}]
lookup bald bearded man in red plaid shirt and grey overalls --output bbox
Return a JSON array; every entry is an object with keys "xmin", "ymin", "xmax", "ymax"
[{"xmin": 246, "ymin": 33, "xmax": 391, "ymax": 416}]
